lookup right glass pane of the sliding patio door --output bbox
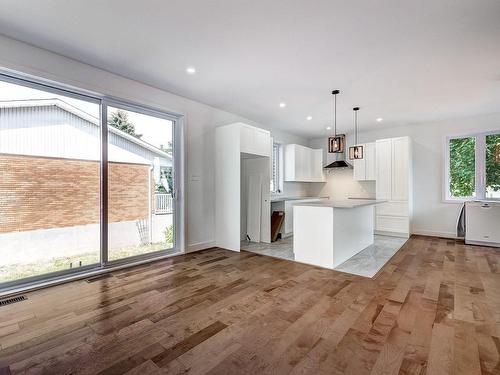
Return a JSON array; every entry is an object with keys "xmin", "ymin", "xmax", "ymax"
[{"xmin": 107, "ymin": 106, "xmax": 175, "ymax": 261}]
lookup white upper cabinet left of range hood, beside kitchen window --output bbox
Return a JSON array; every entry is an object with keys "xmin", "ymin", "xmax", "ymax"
[{"xmin": 284, "ymin": 144, "xmax": 325, "ymax": 182}]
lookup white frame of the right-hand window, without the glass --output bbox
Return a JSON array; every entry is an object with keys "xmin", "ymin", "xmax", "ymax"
[{"xmin": 443, "ymin": 129, "xmax": 500, "ymax": 203}]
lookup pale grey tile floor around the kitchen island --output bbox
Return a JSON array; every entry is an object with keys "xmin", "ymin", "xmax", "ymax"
[{"xmin": 241, "ymin": 235, "xmax": 408, "ymax": 277}]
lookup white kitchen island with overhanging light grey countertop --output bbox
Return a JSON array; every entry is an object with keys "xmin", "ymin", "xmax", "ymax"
[{"xmin": 293, "ymin": 199, "xmax": 385, "ymax": 269}]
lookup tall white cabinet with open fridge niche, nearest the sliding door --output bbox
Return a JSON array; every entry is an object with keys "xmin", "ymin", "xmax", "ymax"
[{"xmin": 215, "ymin": 123, "xmax": 272, "ymax": 251}]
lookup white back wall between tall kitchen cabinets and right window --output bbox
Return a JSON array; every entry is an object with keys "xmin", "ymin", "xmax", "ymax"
[{"xmin": 310, "ymin": 113, "xmax": 500, "ymax": 237}]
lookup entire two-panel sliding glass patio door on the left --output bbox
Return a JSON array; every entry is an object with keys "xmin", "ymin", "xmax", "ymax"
[{"xmin": 0, "ymin": 73, "xmax": 180, "ymax": 293}]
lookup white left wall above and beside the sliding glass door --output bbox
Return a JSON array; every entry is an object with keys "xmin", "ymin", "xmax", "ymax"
[{"xmin": 0, "ymin": 36, "xmax": 307, "ymax": 251}]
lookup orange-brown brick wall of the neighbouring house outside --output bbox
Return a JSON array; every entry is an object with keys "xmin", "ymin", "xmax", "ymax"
[{"xmin": 0, "ymin": 155, "xmax": 149, "ymax": 233}]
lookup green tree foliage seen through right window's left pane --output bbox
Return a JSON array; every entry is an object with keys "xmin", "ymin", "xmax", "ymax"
[{"xmin": 449, "ymin": 137, "xmax": 476, "ymax": 197}]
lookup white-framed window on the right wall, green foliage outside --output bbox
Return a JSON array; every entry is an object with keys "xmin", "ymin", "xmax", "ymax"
[{"xmin": 444, "ymin": 131, "xmax": 500, "ymax": 201}]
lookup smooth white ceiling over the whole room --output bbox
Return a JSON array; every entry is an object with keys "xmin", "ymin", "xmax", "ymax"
[{"xmin": 0, "ymin": 0, "xmax": 500, "ymax": 137}]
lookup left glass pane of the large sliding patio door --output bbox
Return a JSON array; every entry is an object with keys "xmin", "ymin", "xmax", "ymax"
[{"xmin": 0, "ymin": 81, "xmax": 101, "ymax": 285}]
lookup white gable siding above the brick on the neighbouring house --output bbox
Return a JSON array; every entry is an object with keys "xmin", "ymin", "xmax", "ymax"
[{"xmin": 0, "ymin": 105, "xmax": 172, "ymax": 166}]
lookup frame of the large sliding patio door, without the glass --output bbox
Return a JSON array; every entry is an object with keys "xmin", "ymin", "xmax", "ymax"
[{"xmin": 0, "ymin": 67, "xmax": 186, "ymax": 297}]
